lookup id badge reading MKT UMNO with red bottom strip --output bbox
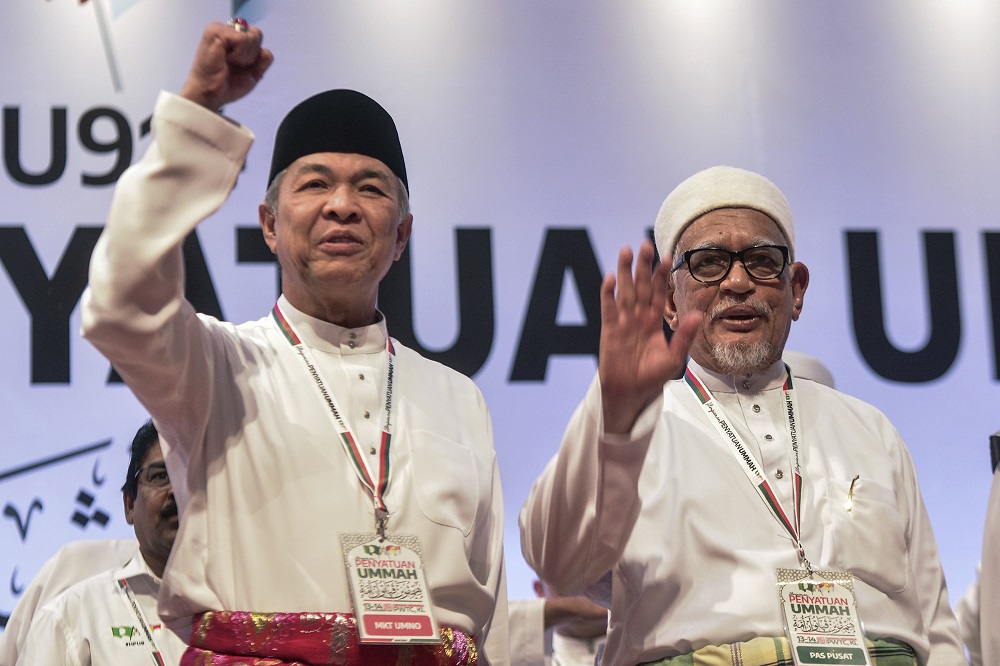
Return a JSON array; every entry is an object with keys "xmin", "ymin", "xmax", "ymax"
[{"xmin": 340, "ymin": 534, "xmax": 441, "ymax": 643}]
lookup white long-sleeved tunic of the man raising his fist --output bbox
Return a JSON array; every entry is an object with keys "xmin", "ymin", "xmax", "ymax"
[{"xmin": 83, "ymin": 93, "xmax": 508, "ymax": 664}]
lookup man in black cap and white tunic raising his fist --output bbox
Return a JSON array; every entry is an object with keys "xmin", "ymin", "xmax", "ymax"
[{"xmin": 82, "ymin": 19, "xmax": 508, "ymax": 666}]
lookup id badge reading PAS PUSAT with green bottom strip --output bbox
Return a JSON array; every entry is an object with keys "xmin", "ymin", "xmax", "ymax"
[{"xmin": 777, "ymin": 569, "xmax": 871, "ymax": 666}]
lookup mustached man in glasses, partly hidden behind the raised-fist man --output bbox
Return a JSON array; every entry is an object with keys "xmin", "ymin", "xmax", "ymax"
[{"xmin": 17, "ymin": 421, "xmax": 187, "ymax": 666}]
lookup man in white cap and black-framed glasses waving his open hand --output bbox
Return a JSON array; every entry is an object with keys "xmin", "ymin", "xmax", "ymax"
[{"xmin": 520, "ymin": 167, "xmax": 966, "ymax": 666}]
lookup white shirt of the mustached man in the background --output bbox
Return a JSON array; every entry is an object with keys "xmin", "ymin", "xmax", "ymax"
[{"xmin": 17, "ymin": 554, "xmax": 187, "ymax": 666}]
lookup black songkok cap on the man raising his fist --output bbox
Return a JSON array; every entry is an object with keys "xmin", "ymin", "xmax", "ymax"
[{"xmin": 267, "ymin": 90, "xmax": 410, "ymax": 193}]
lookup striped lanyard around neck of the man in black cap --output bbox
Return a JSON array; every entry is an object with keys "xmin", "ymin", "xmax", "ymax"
[{"xmin": 271, "ymin": 303, "xmax": 396, "ymax": 538}]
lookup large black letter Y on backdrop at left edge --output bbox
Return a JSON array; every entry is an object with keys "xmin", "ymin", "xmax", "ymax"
[{"xmin": 0, "ymin": 227, "xmax": 101, "ymax": 384}]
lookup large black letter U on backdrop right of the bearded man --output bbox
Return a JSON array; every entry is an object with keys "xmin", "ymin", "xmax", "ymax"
[{"xmin": 846, "ymin": 231, "xmax": 962, "ymax": 384}]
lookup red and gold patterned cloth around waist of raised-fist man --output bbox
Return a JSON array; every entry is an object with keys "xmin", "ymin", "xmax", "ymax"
[{"xmin": 181, "ymin": 611, "xmax": 479, "ymax": 666}]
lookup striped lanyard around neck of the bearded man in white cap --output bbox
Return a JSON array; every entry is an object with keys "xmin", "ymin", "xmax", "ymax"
[{"xmin": 684, "ymin": 364, "xmax": 812, "ymax": 571}]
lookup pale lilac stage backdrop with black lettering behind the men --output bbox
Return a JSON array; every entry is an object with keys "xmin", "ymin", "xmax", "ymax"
[{"xmin": 0, "ymin": 0, "xmax": 1000, "ymax": 615}]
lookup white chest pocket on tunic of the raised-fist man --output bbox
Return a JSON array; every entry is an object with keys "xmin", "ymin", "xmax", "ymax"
[{"xmin": 412, "ymin": 432, "xmax": 480, "ymax": 536}]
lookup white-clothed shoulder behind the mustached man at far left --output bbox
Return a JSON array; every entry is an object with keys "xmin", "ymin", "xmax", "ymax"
[{"xmin": 0, "ymin": 539, "xmax": 139, "ymax": 666}]
